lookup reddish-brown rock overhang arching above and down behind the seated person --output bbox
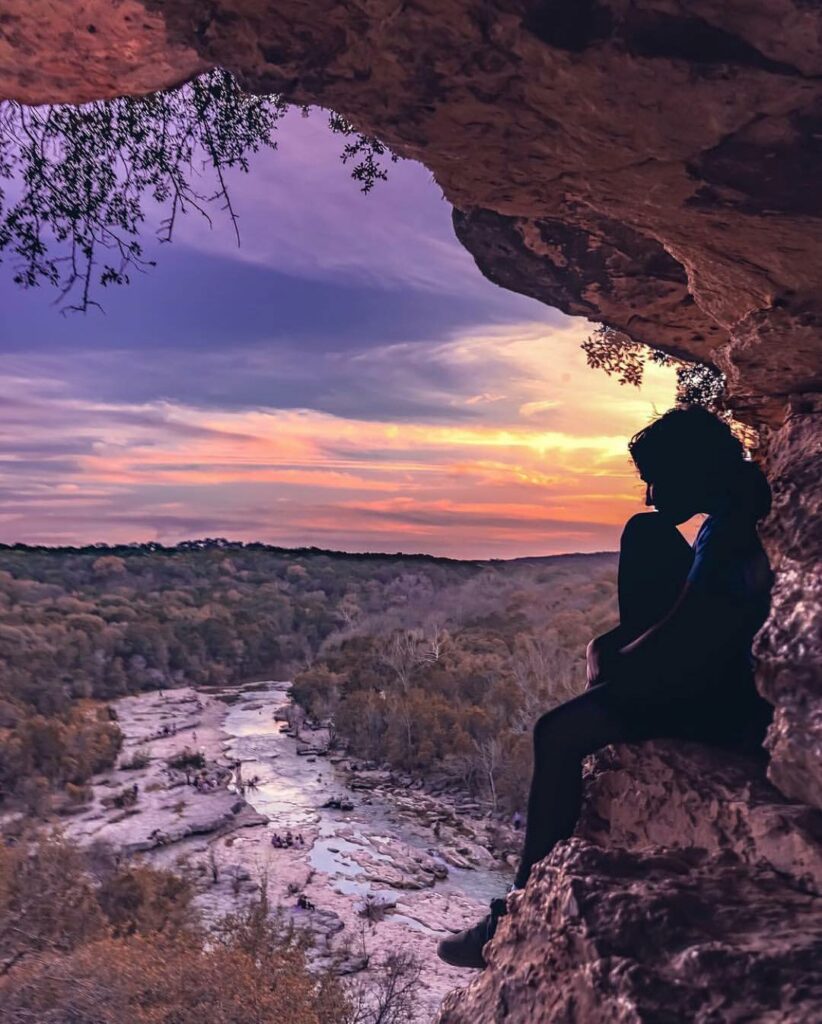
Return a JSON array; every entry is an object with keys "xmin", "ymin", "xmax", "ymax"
[{"xmin": 0, "ymin": 0, "xmax": 822, "ymax": 805}]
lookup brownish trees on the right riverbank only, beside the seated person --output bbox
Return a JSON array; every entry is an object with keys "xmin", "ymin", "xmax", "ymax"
[{"xmin": 293, "ymin": 555, "xmax": 617, "ymax": 812}]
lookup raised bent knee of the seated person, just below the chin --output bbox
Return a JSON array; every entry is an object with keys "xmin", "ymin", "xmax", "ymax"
[{"xmin": 617, "ymin": 512, "xmax": 693, "ymax": 640}]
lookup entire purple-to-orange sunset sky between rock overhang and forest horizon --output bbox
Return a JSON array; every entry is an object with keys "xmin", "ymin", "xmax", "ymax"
[{"xmin": 0, "ymin": 108, "xmax": 674, "ymax": 557}]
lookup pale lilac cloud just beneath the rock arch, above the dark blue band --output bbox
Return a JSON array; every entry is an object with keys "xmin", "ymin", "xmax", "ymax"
[{"xmin": 178, "ymin": 110, "xmax": 507, "ymax": 297}]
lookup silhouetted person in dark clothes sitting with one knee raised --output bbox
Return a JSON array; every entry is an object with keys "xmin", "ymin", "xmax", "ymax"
[{"xmin": 438, "ymin": 407, "xmax": 772, "ymax": 968}]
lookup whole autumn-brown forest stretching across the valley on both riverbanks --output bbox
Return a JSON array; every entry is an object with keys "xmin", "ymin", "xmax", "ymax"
[{"xmin": 0, "ymin": 540, "xmax": 616, "ymax": 811}]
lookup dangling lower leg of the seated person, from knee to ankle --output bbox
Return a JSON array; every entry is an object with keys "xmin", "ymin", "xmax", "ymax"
[{"xmin": 514, "ymin": 683, "xmax": 639, "ymax": 889}]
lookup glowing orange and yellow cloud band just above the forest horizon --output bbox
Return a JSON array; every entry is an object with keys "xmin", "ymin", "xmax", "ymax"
[{"xmin": 0, "ymin": 322, "xmax": 673, "ymax": 556}]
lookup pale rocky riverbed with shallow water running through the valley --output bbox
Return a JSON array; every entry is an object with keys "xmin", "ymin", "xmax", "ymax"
[{"xmin": 66, "ymin": 683, "xmax": 516, "ymax": 1022}]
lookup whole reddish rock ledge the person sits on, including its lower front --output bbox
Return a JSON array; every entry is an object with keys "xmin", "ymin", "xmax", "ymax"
[{"xmin": 439, "ymin": 740, "xmax": 822, "ymax": 1024}]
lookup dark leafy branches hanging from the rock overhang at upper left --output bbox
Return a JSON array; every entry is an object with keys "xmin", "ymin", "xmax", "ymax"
[{"xmin": 0, "ymin": 70, "xmax": 397, "ymax": 312}]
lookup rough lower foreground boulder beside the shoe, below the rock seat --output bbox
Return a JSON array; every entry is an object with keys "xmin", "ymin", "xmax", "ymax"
[{"xmin": 438, "ymin": 839, "xmax": 822, "ymax": 1024}]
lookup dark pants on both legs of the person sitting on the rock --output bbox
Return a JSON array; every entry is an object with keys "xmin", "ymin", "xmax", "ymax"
[{"xmin": 515, "ymin": 512, "xmax": 770, "ymax": 888}]
